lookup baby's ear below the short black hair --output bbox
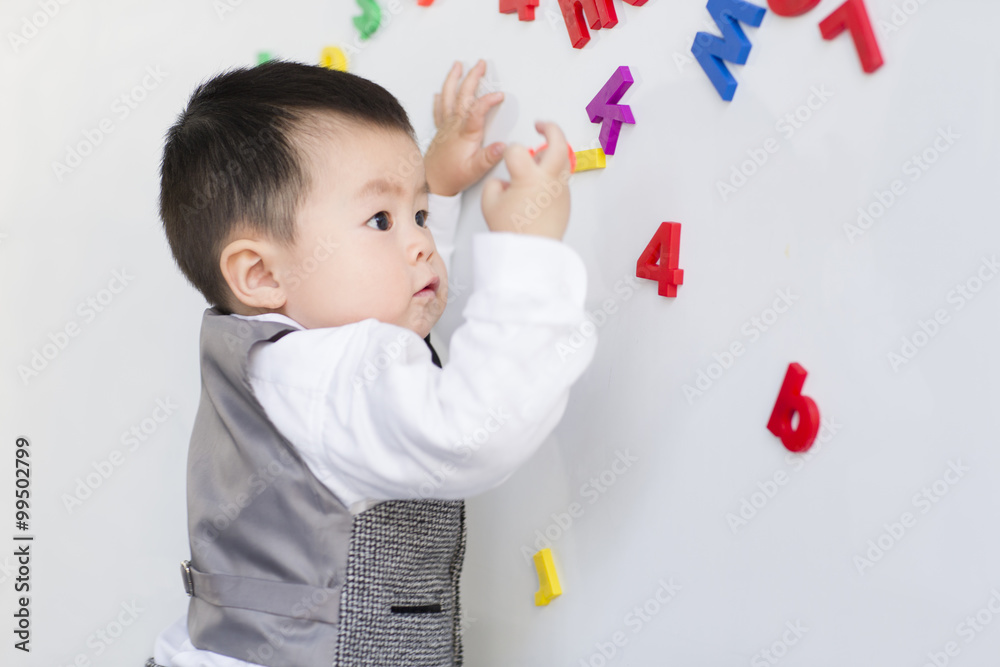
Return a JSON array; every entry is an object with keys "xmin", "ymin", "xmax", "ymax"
[{"xmin": 219, "ymin": 239, "xmax": 287, "ymax": 310}]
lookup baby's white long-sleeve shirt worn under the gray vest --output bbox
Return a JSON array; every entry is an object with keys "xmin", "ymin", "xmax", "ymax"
[{"xmin": 154, "ymin": 194, "xmax": 597, "ymax": 667}]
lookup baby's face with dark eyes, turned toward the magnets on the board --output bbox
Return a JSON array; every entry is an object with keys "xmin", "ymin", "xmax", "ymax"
[{"xmin": 280, "ymin": 123, "xmax": 448, "ymax": 338}]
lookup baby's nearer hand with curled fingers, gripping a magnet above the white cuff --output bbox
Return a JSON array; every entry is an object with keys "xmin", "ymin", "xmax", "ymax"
[{"xmin": 482, "ymin": 122, "xmax": 570, "ymax": 240}]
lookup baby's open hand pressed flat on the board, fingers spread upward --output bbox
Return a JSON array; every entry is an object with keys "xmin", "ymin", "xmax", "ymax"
[{"xmin": 424, "ymin": 60, "xmax": 504, "ymax": 197}]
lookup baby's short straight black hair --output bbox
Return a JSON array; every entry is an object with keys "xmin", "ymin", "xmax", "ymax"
[{"xmin": 160, "ymin": 60, "xmax": 417, "ymax": 313}]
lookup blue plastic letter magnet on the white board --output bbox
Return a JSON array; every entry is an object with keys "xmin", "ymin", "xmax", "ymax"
[{"xmin": 691, "ymin": 0, "xmax": 767, "ymax": 102}]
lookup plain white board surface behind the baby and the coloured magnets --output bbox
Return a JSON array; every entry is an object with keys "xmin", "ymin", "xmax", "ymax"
[{"xmin": 0, "ymin": 0, "xmax": 1000, "ymax": 667}]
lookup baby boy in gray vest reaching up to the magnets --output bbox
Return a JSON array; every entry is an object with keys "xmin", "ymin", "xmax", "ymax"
[{"xmin": 147, "ymin": 61, "xmax": 597, "ymax": 667}]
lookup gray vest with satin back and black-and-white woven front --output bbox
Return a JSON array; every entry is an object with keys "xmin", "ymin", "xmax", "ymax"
[{"xmin": 181, "ymin": 308, "xmax": 465, "ymax": 667}]
